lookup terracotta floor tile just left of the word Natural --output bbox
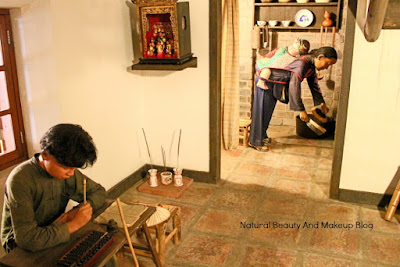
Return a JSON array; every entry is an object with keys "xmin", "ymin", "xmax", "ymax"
[{"xmin": 195, "ymin": 210, "xmax": 248, "ymax": 236}]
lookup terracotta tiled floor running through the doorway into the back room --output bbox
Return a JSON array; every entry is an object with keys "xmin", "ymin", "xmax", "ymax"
[{"xmin": 121, "ymin": 128, "xmax": 400, "ymax": 267}]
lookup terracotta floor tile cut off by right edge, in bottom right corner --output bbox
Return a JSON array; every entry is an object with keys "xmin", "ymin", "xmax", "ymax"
[{"xmin": 364, "ymin": 233, "xmax": 400, "ymax": 266}]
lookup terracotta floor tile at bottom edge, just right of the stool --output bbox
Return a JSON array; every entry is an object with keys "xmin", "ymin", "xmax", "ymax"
[{"xmin": 175, "ymin": 235, "xmax": 233, "ymax": 266}]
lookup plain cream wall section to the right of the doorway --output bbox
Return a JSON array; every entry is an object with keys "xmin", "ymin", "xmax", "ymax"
[{"xmin": 340, "ymin": 27, "xmax": 400, "ymax": 193}]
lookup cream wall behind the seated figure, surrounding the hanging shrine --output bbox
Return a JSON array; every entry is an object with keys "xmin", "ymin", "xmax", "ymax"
[{"xmin": 7, "ymin": 0, "xmax": 209, "ymax": 189}]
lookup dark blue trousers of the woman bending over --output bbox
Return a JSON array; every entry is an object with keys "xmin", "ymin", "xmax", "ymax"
[{"xmin": 249, "ymin": 76, "xmax": 277, "ymax": 146}]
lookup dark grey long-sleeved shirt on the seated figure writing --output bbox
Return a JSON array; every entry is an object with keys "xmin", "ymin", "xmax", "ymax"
[{"xmin": 1, "ymin": 154, "xmax": 106, "ymax": 251}]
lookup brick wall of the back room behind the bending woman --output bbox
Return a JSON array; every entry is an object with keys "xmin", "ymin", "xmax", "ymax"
[{"xmin": 239, "ymin": 0, "xmax": 347, "ymax": 126}]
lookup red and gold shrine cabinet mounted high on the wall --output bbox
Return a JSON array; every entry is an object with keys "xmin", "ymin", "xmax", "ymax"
[{"xmin": 132, "ymin": 0, "xmax": 197, "ymax": 69}]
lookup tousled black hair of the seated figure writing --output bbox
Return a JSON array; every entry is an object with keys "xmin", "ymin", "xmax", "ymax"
[{"xmin": 40, "ymin": 124, "xmax": 97, "ymax": 168}]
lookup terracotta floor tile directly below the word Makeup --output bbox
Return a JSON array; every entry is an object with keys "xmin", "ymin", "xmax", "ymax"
[{"xmin": 310, "ymin": 228, "xmax": 360, "ymax": 256}]
